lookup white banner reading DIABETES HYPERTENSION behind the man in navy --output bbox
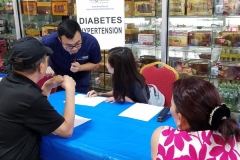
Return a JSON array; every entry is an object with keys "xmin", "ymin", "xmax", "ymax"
[{"xmin": 76, "ymin": 0, "xmax": 125, "ymax": 49}]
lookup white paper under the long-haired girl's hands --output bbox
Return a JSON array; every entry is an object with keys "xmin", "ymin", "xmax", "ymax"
[{"xmin": 75, "ymin": 94, "xmax": 106, "ymax": 107}]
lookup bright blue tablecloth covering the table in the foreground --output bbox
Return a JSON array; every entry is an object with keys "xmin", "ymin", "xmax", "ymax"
[{"xmin": 41, "ymin": 92, "xmax": 176, "ymax": 160}]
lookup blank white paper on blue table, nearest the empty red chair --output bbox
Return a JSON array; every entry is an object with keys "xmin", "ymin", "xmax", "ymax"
[{"xmin": 119, "ymin": 103, "xmax": 163, "ymax": 121}]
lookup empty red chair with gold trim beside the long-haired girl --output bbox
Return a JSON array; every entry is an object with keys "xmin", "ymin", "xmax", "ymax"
[{"xmin": 140, "ymin": 62, "xmax": 179, "ymax": 107}]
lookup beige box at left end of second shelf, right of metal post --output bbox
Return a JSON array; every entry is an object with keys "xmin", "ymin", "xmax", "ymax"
[{"xmin": 169, "ymin": 30, "xmax": 188, "ymax": 46}]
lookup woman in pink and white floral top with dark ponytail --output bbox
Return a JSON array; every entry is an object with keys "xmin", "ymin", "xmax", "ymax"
[{"xmin": 151, "ymin": 77, "xmax": 240, "ymax": 160}]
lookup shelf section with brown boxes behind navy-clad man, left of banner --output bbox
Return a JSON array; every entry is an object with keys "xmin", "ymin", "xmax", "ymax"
[{"xmin": 19, "ymin": 0, "xmax": 76, "ymax": 38}]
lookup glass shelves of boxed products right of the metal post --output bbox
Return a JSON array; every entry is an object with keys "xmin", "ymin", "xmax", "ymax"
[{"xmin": 164, "ymin": 0, "xmax": 240, "ymax": 118}]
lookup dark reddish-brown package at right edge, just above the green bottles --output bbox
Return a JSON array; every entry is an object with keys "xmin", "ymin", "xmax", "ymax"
[{"xmin": 218, "ymin": 62, "xmax": 240, "ymax": 80}]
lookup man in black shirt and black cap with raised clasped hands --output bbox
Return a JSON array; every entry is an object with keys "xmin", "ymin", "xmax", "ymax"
[{"xmin": 0, "ymin": 37, "xmax": 76, "ymax": 160}]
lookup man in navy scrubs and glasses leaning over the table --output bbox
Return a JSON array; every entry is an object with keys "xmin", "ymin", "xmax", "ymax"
[{"xmin": 41, "ymin": 19, "xmax": 102, "ymax": 93}]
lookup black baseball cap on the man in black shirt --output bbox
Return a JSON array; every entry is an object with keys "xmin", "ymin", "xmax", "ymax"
[{"xmin": 9, "ymin": 36, "xmax": 53, "ymax": 64}]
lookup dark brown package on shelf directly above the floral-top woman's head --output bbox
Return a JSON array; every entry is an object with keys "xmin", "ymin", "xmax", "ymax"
[{"xmin": 188, "ymin": 59, "xmax": 210, "ymax": 76}]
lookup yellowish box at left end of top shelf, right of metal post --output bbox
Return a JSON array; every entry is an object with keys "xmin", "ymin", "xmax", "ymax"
[{"xmin": 169, "ymin": 0, "xmax": 185, "ymax": 15}]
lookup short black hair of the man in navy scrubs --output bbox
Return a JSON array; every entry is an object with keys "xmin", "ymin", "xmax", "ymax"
[{"xmin": 57, "ymin": 19, "xmax": 82, "ymax": 39}]
